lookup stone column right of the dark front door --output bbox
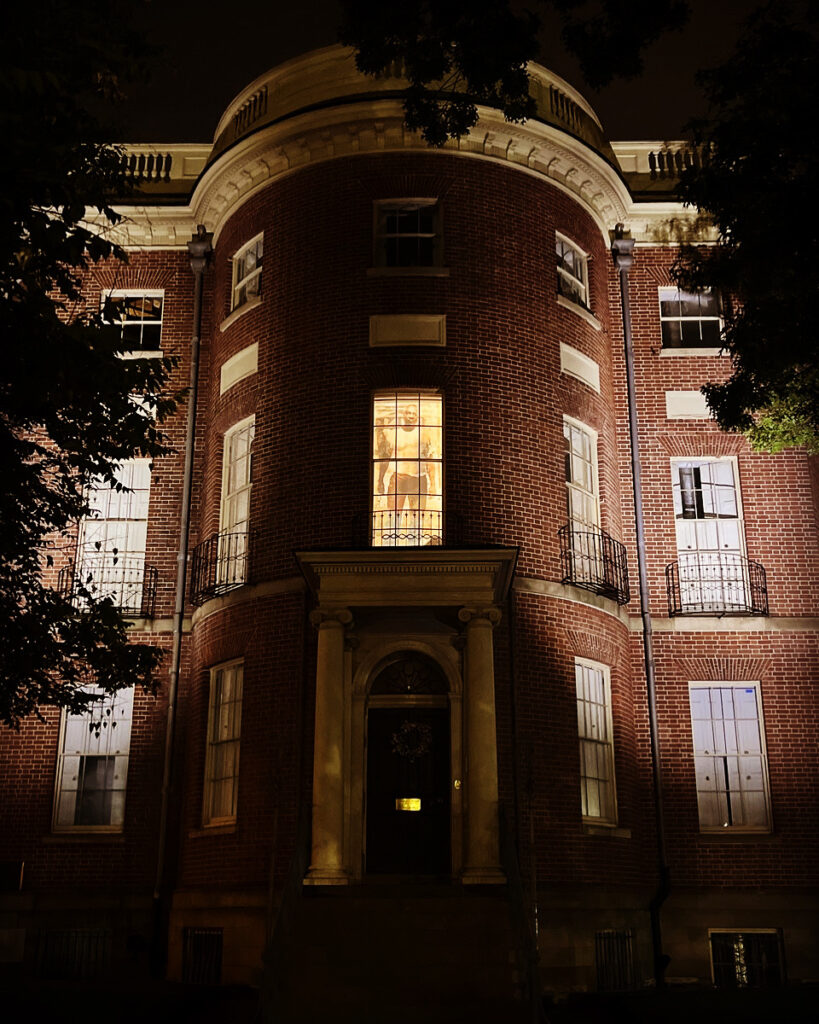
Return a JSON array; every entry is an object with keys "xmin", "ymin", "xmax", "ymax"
[{"xmin": 458, "ymin": 607, "xmax": 506, "ymax": 884}]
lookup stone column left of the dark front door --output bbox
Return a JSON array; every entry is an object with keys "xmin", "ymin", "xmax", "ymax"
[{"xmin": 304, "ymin": 608, "xmax": 352, "ymax": 885}]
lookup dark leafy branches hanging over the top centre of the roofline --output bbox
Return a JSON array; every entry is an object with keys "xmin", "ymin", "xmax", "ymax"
[{"xmin": 340, "ymin": 0, "xmax": 688, "ymax": 145}]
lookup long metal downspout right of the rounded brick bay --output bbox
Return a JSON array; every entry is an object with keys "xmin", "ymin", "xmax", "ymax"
[{"xmin": 611, "ymin": 230, "xmax": 671, "ymax": 988}]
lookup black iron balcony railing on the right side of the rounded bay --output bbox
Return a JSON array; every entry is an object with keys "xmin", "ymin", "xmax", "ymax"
[{"xmin": 557, "ymin": 522, "xmax": 631, "ymax": 604}]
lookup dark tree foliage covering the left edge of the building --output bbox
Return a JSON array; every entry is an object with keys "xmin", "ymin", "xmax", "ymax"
[{"xmin": 0, "ymin": 6, "xmax": 173, "ymax": 726}]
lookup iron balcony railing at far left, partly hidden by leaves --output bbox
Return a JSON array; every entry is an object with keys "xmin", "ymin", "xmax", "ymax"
[{"xmin": 57, "ymin": 553, "xmax": 157, "ymax": 618}]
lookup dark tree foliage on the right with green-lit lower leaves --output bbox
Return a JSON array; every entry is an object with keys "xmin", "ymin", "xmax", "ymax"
[{"xmin": 676, "ymin": 0, "xmax": 819, "ymax": 453}]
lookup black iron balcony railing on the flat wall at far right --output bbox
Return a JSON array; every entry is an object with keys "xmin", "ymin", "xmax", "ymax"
[{"xmin": 665, "ymin": 551, "xmax": 768, "ymax": 615}]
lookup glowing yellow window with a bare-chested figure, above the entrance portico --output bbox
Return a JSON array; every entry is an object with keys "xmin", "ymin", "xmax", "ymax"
[{"xmin": 373, "ymin": 391, "xmax": 443, "ymax": 548}]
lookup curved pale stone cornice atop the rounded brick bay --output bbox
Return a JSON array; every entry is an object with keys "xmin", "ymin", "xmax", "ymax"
[{"xmin": 190, "ymin": 99, "xmax": 632, "ymax": 244}]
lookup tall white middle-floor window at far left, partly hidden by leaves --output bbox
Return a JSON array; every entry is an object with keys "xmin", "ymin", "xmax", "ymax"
[{"xmin": 77, "ymin": 459, "xmax": 150, "ymax": 614}]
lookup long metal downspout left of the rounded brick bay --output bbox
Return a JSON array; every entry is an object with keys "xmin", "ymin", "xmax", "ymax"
[{"xmin": 154, "ymin": 224, "xmax": 213, "ymax": 969}]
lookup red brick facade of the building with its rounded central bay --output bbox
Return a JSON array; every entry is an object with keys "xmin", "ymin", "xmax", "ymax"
[{"xmin": 0, "ymin": 48, "xmax": 819, "ymax": 990}]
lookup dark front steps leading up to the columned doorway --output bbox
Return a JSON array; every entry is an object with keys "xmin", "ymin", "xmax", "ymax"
[{"xmin": 278, "ymin": 885, "xmax": 527, "ymax": 1024}]
